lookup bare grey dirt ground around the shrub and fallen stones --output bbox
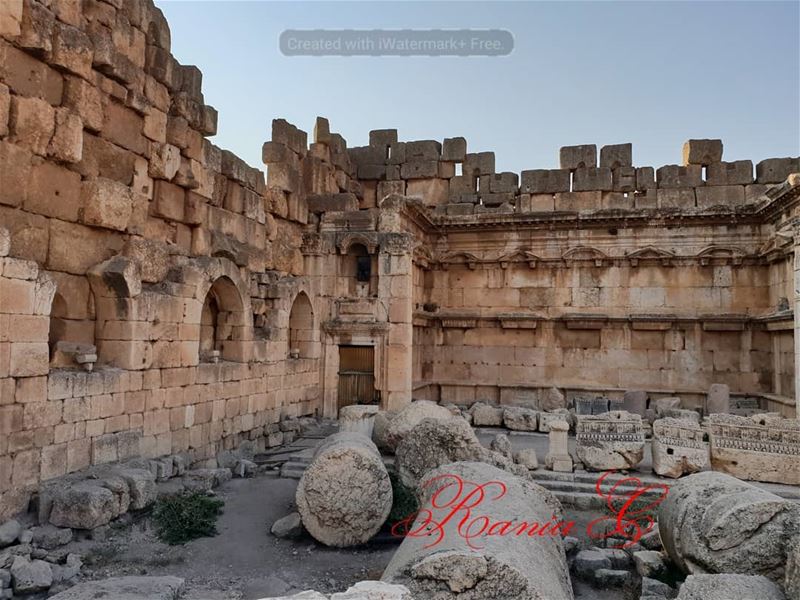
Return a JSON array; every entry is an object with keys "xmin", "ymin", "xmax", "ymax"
[{"xmin": 56, "ymin": 473, "xmax": 622, "ymax": 600}]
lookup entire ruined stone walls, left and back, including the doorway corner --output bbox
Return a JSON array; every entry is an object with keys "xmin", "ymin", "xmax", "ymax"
[{"xmin": 0, "ymin": 0, "xmax": 800, "ymax": 516}]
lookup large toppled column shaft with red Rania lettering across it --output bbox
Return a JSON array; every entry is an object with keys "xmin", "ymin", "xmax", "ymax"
[{"xmin": 382, "ymin": 462, "xmax": 573, "ymax": 600}]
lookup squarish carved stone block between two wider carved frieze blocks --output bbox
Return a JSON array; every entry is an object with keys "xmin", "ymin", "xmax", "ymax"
[{"xmin": 652, "ymin": 417, "xmax": 709, "ymax": 479}]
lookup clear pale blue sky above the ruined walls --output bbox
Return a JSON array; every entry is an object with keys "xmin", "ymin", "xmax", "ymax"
[{"xmin": 157, "ymin": 0, "xmax": 800, "ymax": 172}]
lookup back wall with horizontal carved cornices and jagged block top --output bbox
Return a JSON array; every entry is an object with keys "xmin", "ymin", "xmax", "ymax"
[{"xmin": 344, "ymin": 135, "xmax": 800, "ymax": 414}]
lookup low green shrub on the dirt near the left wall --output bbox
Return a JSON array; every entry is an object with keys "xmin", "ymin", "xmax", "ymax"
[{"xmin": 153, "ymin": 492, "xmax": 225, "ymax": 545}]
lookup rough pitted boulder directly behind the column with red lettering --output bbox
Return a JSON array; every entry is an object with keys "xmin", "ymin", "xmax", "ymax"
[{"xmin": 396, "ymin": 417, "xmax": 485, "ymax": 490}]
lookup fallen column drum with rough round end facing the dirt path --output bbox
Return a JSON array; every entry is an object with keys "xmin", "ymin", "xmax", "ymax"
[{"xmin": 295, "ymin": 432, "xmax": 392, "ymax": 548}]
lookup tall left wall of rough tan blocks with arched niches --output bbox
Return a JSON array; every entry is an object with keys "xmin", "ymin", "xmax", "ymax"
[{"xmin": 0, "ymin": 0, "xmax": 321, "ymax": 518}]
